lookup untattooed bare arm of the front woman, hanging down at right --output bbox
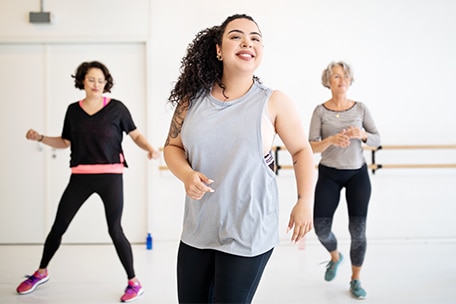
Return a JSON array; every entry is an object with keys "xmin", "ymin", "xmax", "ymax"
[{"xmin": 269, "ymin": 91, "xmax": 315, "ymax": 243}]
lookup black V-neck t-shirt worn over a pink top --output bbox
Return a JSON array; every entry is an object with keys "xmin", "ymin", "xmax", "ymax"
[{"xmin": 62, "ymin": 99, "xmax": 136, "ymax": 167}]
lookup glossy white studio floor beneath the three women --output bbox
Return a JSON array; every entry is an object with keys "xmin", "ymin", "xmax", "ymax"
[{"xmin": 0, "ymin": 240, "xmax": 456, "ymax": 304}]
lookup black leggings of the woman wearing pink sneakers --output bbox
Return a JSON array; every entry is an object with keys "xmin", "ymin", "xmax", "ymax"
[{"xmin": 40, "ymin": 174, "xmax": 135, "ymax": 279}]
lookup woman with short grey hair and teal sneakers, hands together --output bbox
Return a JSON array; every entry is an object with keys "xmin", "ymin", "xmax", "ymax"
[{"xmin": 309, "ymin": 61, "xmax": 380, "ymax": 299}]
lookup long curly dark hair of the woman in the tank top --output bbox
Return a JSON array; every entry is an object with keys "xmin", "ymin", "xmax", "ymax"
[{"xmin": 168, "ymin": 14, "xmax": 260, "ymax": 108}]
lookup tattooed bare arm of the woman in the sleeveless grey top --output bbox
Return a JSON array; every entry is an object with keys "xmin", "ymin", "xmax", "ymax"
[{"xmin": 163, "ymin": 105, "xmax": 214, "ymax": 200}]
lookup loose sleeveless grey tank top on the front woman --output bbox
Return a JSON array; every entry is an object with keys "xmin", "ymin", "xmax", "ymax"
[{"xmin": 181, "ymin": 81, "xmax": 279, "ymax": 257}]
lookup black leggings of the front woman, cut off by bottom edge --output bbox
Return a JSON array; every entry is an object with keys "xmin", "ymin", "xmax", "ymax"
[{"xmin": 177, "ymin": 242, "xmax": 273, "ymax": 303}]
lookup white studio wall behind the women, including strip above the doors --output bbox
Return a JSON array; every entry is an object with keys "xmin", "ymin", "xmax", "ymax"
[{"xmin": 0, "ymin": 0, "xmax": 456, "ymax": 239}]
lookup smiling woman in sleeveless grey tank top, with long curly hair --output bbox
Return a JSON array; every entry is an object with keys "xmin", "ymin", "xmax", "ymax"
[{"xmin": 164, "ymin": 15, "xmax": 314, "ymax": 303}]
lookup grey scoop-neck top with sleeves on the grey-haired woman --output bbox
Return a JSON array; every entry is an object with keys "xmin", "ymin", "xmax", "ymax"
[{"xmin": 309, "ymin": 102, "xmax": 380, "ymax": 169}]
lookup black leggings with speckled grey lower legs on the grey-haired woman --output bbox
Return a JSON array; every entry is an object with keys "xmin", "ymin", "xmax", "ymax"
[{"xmin": 314, "ymin": 165, "xmax": 371, "ymax": 267}]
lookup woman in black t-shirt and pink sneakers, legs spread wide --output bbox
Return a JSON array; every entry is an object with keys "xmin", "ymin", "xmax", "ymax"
[{"xmin": 17, "ymin": 61, "xmax": 159, "ymax": 302}]
